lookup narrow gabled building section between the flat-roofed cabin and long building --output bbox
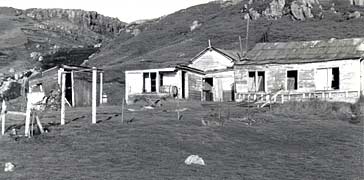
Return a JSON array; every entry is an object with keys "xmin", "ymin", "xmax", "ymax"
[{"xmin": 189, "ymin": 43, "xmax": 240, "ymax": 101}]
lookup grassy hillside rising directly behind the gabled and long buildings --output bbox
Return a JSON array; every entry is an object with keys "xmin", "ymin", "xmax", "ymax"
[{"xmin": 87, "ymin": 1, "xmax": 364, "ymax": 104}]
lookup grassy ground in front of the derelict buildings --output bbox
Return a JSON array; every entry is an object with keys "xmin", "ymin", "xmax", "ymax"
[{"xmin": 0, "ymin": 102, "xmax": 364, "ymax": 180}]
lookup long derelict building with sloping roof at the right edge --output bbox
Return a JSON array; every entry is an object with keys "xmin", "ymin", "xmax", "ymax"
[{"xmin": 234, "ymin": 38, "xmax": 364, "ymax": 102}]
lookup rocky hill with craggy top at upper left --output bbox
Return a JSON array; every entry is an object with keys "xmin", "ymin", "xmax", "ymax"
[{"xmin": 0, "ymin": 7, "xmax": 125, "ymax": 73}]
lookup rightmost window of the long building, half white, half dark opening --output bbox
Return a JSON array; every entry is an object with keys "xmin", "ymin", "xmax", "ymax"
[{"xmin": 315, "ymin": 67, "xmax": 340, "ymax": 90}]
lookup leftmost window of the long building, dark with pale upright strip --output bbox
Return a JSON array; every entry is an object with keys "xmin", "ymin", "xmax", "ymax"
[{"xmin": 248, "ymin": 71, "xmax": 265, "ymax": 91}]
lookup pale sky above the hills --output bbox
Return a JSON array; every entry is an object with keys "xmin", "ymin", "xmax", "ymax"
[{"xmin": 0, "ymin": 0, "xmax": 211, "ymax": 23}]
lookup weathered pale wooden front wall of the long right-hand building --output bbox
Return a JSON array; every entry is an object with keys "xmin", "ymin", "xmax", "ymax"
[{"xmin": 234, "ymin": 60, "xmax": 360, "ymax": 93}]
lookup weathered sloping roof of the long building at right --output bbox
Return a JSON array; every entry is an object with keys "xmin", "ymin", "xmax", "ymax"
[{"xmin": 237, "ymin": 38, "xmax": 364, "ymax": 64}]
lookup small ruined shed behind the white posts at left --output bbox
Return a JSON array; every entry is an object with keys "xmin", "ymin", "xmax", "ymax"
[{"xmin": 28, "ymin": 65, "xmax": 103, "ymax": 107}]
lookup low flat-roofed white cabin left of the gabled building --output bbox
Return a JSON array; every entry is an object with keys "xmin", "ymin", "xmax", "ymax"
[{"xmin": 125, "ymin": 65, "xmax": 203, "ymax": 103}]
